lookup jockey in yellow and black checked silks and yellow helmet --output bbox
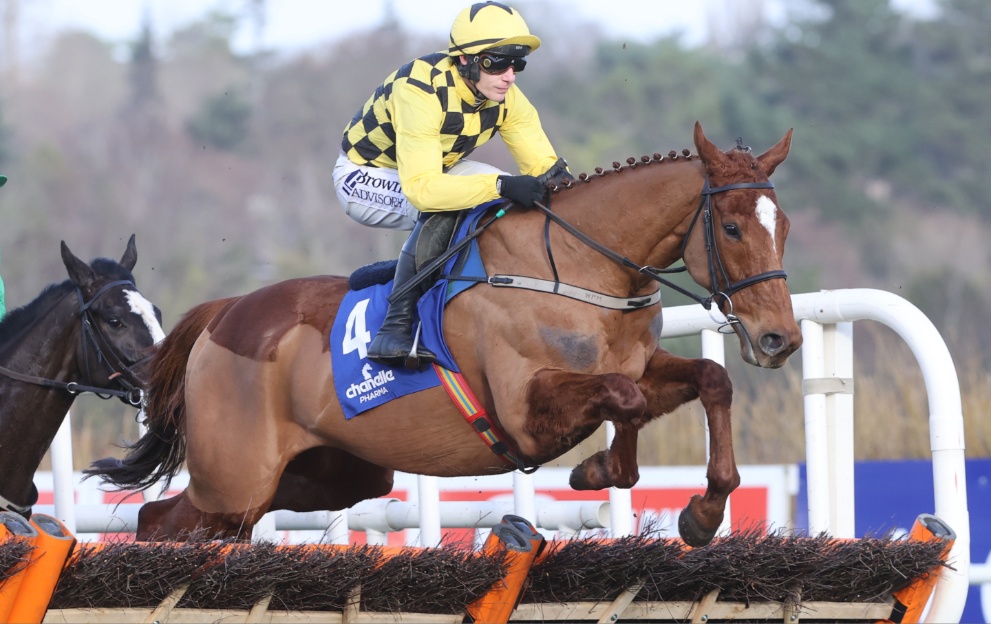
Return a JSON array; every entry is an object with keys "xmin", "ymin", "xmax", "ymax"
[{"xmin": 334, "ymin": 2, "xmax": 570, "ymax": 365}]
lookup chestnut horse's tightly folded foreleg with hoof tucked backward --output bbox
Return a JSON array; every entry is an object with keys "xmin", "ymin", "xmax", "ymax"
[{"xmin": 527, "ymin": 370, "xmax": 647, "ymax": 490}]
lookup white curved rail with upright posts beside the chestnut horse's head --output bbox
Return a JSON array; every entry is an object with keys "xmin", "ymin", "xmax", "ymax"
[{"xmin": 661, "ymin": 288, "xmax": 970, "ymax": 622}]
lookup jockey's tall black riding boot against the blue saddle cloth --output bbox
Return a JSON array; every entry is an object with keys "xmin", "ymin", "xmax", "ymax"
[{"xmin": 368, "ymin": 221, "xmax": 437, "ymax": 367}]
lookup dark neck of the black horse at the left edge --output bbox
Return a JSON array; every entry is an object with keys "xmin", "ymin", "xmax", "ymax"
[{"xmin": 0, "ymin": 295, "xmax": 80, "ymax": 504}]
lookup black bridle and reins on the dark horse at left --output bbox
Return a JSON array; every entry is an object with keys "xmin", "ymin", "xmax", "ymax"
[{"xmin": 0, "ymin": 280, "xmax": 152, "ymax": 406}]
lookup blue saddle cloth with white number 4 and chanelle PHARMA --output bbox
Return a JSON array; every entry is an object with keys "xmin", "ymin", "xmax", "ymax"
[{"xmin": 330, "ymin": 202, "xmax": 498, "ymax": 419}]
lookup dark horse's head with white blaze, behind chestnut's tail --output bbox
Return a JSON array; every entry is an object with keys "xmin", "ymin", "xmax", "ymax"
[{"xmin": 62, "ymin": 234, "xmax": 165, "ymax": 401}]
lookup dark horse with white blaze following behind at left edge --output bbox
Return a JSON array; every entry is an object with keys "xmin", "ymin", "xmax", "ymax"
[{"xmin": 0, "ymin": 235, "xmax": 165, "ymax": 516}]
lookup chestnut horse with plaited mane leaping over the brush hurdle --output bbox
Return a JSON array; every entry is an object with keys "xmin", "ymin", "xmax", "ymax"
[{"xmin": 89, "ymin": 124, "xmax": 801, "ymax": 545}]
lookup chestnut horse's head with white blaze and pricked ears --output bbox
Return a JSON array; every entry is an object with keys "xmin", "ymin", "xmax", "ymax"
[{"xmin": 684, "ymin": 122, "xmax": 802, "ymax": 368}]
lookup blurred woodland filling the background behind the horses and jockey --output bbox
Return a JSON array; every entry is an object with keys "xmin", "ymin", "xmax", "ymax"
[{"xmin": 0, "ymin": 0, "xmax": 991, "ymax": 463}]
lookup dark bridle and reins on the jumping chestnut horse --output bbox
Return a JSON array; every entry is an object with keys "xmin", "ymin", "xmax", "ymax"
[{"xmin": 536, "ymin": 176, "xmax": 787, "ymax": 330}]
